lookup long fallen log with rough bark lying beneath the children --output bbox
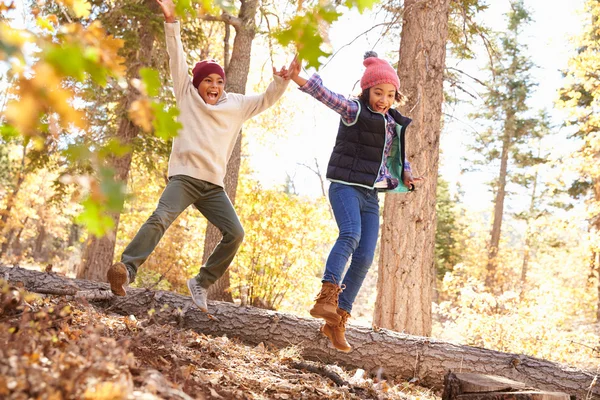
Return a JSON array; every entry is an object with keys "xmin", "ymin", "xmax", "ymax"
[{"xmin": 0, "ymin": 266, "xmax": 600, "ymax": 399}]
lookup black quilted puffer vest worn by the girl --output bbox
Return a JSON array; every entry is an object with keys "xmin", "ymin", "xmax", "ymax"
[{"xmin": 326, "ymin": 100, "xmax": 410, "ymax": 189}]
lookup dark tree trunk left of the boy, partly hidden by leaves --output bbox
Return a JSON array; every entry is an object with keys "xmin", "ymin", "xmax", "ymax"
[{"xmin": 77, "ymin": 10, "xmax": 156, "ymax": 281}]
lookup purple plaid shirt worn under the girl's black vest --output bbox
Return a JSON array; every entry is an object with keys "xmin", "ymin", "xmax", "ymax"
[{"xmin": 299, "ymin": 74, "xmax": 411, "ymax": 186}]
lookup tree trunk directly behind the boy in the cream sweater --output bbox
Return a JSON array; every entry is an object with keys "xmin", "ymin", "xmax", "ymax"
[{"xmin": 202, "ymin": 0, "xmax": 258, "ymax": 301}]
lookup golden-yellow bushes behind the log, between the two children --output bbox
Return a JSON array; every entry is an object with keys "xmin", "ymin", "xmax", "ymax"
[{"xmin": 231, "ymin": 178, "xmax": 336, "ymax": 312}]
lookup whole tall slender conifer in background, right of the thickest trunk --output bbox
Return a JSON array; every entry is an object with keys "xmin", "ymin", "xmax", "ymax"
[{"xmin": 466, "ymin": 0, "xmax": 536, "ymax": 288}]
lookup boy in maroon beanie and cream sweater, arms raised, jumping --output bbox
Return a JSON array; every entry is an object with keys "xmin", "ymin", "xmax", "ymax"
[{"xmin": 107, "ymin": 0, "xmax": 289, "ymax": 312}]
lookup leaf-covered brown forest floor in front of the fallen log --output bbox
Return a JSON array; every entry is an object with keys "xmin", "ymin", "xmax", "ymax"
[{"xmin": 0, "ymin": 281, "xmax": 439, "ymax": 400}]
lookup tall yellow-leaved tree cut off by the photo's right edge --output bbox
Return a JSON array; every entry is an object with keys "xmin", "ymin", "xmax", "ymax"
[{"xmin": 559, "ymin": 0, "xmax": 600, "ymax": 321}]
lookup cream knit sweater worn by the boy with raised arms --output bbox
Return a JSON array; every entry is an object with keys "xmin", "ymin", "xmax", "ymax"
[{"xmin": 165, "ymin": 21, "xmax": 289, "ymax": 187}]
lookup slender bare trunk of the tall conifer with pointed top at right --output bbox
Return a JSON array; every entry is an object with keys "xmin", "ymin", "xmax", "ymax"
[{"xmin": 485, "ymin": 119, "xmax": 512, "ymax": 289}]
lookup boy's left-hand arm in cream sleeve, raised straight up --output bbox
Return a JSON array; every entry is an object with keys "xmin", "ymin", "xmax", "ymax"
[{"xmin": 156, "ymin": 0, "xmax": 190, "ymax": 98}]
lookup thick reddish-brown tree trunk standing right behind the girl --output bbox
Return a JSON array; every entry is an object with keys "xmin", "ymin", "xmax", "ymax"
[{"xmin": 373, "ymin": 0, "xmax": 449, "ymax": 336}]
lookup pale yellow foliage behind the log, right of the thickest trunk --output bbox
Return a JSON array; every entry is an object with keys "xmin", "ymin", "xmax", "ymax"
[{"xmin": 433, "ymin": 212, "xmax": 599, "ymax": 368}]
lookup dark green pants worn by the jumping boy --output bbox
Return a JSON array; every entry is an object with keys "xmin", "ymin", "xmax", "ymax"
[{"xmin": 121, "ymin": 175, "xmax": 244, "ymax": 288}]
